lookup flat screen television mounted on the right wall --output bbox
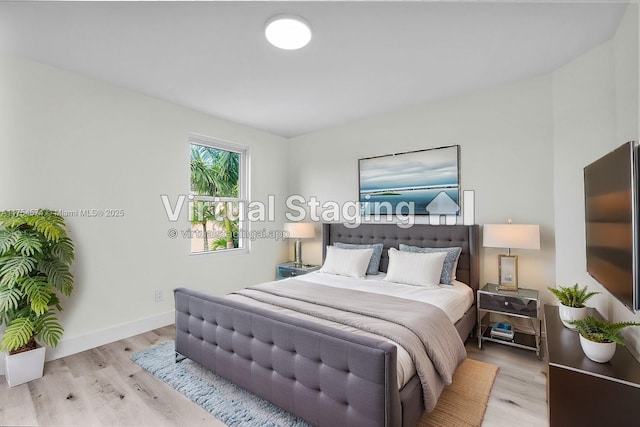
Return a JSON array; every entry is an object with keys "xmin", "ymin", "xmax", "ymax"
[{"xmin": 584, "ymin": 142, "xmax": 640, "ymax": 311}]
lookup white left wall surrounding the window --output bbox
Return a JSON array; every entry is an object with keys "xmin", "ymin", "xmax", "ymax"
[{"xmin": 0, "ymin": 54, "xmax": 288, "ymax": 364}]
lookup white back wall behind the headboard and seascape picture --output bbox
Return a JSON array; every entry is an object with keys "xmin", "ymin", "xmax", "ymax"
[{"xmin": 289, "ymin": 76, "xmax": 555, "ymax": 289}]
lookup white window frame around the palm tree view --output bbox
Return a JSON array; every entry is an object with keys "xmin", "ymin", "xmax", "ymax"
[{"xmin": 187, "ymin": 134, "xmax": 251, "ymax": 256}]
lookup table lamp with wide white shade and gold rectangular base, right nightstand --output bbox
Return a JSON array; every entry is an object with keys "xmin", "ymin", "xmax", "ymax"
[{"xmin": 482, "ymin": 220, "xmax": 540, "ymax": 290}]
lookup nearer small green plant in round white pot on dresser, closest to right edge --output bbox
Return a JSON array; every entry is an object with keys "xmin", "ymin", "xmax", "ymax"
[{"xmin": 569, "ymin": 316, "xmax": 640, "ymax": 363}]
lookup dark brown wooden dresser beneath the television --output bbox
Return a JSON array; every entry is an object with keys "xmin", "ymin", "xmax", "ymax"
[{"xmin": 544, "ymin": 305, "xmax": 640, "ymax": 427}]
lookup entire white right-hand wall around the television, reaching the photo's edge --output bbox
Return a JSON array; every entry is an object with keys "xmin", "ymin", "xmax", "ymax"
[{"xmin": 553, "ymin": 4, "xmax": 640, "ymax": 354}]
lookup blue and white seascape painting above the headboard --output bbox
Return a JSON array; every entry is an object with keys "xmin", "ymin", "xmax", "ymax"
[{"xmin": 358, "ymin": 145, "xmax": 460, "ymax": 215}]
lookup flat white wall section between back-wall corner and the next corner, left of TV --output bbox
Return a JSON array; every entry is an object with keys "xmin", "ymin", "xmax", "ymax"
[{"xmin": 553, "ymin": 43, "xmax": 620, "ymax": 294}]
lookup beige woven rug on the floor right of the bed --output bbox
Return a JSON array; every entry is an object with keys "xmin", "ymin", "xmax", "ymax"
[{"xmin": 418, "ymin": 358, "xmax": 498, "ymax": 427}]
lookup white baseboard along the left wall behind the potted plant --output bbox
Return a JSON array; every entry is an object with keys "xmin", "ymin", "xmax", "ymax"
[{"xmin": 0, "ymin": 310, "xmax": 175, "ymax": 375}]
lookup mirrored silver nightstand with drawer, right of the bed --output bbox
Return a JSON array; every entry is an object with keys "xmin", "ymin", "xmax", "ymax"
[{"xmin": 477, "ymin": 283, "xmax": 541, "ymax": 359}]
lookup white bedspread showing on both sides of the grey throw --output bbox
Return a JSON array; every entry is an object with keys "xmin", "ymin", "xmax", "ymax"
[{"xmin": 225, "ymin": 272, "xmax": 473, "ymax": 388}]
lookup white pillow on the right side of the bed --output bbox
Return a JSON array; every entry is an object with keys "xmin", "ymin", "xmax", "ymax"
[{"xmin": 383, "ymin": 248, "xmax": 447, "ymax": 289}]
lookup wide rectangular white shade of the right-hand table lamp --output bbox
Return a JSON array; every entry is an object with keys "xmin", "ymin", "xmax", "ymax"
[{"xmin": 482, "ymin": 224, "xmax": 540, "ymax": 249}]
